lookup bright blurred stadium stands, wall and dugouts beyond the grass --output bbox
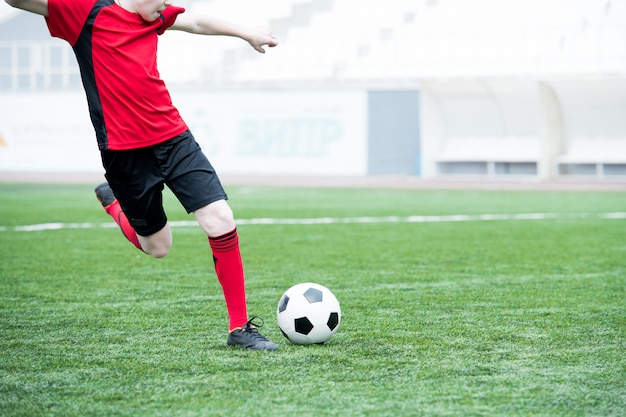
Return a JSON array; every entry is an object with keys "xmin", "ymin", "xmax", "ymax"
[{"xmin": 0, "ymin": 0, "xmax": 626, "ymax": 183}]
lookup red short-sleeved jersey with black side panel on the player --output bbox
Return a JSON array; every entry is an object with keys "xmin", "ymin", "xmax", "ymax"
[{"xmin": 46, "ymin": 0, "xmax": 187, "ymax": 150}]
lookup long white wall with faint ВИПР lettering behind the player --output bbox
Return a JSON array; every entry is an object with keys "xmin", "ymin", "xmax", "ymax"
[{"xmin": 0, "ymin": 91, "xmax": 367, "ymax": 175}]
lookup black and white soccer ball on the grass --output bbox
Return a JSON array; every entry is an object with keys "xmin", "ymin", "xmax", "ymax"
[{"xmin": 276, "ymin": 282, "xmax": 341, "ymax": 345}]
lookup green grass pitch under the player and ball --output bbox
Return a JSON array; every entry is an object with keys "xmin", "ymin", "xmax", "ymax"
[{"xmin": 0, "ymin": 184, "xmax": 626, "ymax": 417}]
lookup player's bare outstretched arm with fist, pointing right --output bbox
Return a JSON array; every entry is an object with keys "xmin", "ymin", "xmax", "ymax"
[{"xmin": 170, "ymin": 13, "xmax": 278, "ymax": 53}]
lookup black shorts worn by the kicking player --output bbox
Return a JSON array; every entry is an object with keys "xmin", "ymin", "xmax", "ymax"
[{"xmin": 101, "ymin": 131, "xmax": 228, "ymax": 236}]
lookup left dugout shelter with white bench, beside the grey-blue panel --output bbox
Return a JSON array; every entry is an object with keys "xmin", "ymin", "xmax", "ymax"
[{"xmin": 421, "ymin": 79, "xmax": 543, "ymax": 177}]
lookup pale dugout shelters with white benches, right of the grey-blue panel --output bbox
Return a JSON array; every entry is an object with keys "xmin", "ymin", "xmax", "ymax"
[{"xmin": 421, "ymin": 78, "xmax": 626, "ymax": 179}]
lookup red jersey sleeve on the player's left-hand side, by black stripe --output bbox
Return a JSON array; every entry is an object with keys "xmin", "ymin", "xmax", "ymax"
[{"xmin": 46, "ymin": 0, "xmax": 97, "ymax": 46}]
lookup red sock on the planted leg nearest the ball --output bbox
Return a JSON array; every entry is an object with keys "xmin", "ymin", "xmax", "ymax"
[{"xmin": 209, "ymin": 229, "xmax": 248, "ymax": 330}]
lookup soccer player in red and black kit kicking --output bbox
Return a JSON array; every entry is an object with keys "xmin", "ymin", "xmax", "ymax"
[{"xmin": 5, "ymin": 0, "xmax": 278, "ymax": 350}]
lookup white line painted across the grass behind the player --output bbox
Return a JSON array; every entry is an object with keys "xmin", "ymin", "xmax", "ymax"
[{"xmin": 0, "ymin": 212, "xmax": 626, "ymax": 232}]
